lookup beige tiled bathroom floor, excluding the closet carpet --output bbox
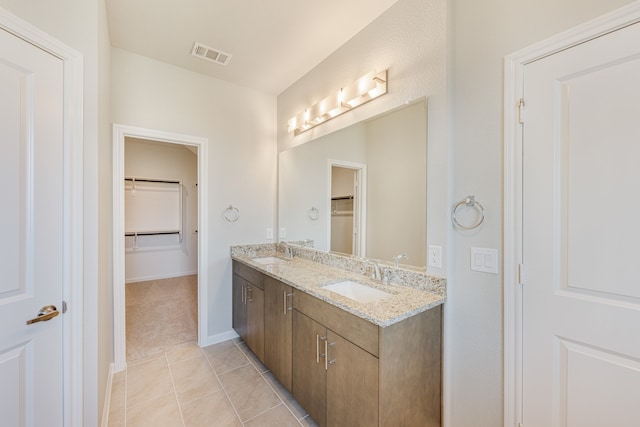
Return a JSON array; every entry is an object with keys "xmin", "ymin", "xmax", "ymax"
[{"xmin": 108, "ymin": 340, "xmax": 316, "ymax": 427}]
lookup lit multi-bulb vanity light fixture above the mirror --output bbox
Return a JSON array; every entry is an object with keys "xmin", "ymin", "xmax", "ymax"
[{"xmin": 288, "ymin": 70, "xmax": 387, "ymax": 136}]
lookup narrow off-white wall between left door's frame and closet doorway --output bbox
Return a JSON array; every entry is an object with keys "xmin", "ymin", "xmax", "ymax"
[{"xmin": 0, "ymin": 0, "xmax": 111, "ymax": 425}]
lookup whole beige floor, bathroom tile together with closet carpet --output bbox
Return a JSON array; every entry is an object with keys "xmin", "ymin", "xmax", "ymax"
[{"xmin": 117, "ymin": 275, "xmax": 315, "ymax": 427}]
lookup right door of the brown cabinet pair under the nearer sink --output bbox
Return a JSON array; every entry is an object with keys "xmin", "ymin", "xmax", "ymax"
[{"xmin": 327, "ymin": 330, "xmax": 378, "ymax": 427}]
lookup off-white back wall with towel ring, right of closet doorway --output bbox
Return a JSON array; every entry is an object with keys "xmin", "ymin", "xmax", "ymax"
[{"xmin": 111, "ymin": 49, "xmax": 277, "ymax": 340}]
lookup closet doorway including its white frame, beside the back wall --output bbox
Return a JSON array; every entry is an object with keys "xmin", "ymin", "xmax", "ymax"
[{"xmin": 113, "ymin": 125, "xmax": 207, "ymax": 371}]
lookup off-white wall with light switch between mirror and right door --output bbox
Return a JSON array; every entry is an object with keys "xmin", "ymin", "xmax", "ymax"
[{"xmin": 445, "ymin": 0, "xmax": 630, "ymax": 427}]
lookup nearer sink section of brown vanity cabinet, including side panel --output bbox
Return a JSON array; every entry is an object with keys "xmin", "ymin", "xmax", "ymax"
[{"xmin": 292, "ymin": 291, "xmax": 442, "ymax": 427}]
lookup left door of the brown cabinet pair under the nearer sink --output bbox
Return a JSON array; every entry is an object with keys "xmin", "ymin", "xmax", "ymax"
[{"xmin": 291, "ymin": 310, "xmax": 327, "ymax": 427}]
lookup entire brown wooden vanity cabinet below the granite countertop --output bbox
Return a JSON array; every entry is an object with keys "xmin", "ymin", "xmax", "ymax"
[{"xmin": 233, "ymin": 261, "xmax": 442, "ymax": 427}]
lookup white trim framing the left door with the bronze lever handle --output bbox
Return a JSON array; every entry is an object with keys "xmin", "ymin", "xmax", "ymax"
[{"xmin": 0, "ymin": 8, "xmax": 84, "ymax": 426}]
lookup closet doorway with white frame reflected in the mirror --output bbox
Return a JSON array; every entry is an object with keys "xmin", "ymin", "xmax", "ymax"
[{"xmin": 327, "ymin": 160, "xmax": 366, "ymax": 256}]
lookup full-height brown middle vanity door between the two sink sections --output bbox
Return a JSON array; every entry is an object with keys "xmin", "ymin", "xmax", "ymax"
[{"xmin": 264, "ymin": 277, "xmax": 293, "ymax": 392}]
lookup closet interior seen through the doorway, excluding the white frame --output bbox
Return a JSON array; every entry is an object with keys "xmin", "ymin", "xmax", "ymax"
[{"xmin": 123, "ymin": 137, "xmax": 198, "ymax": 362}]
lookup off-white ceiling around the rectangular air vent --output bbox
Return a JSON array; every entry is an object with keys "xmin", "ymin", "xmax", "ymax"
[{"xmin": 106, "ymin": 0, "xmax": 397, "ymax": 95}]
